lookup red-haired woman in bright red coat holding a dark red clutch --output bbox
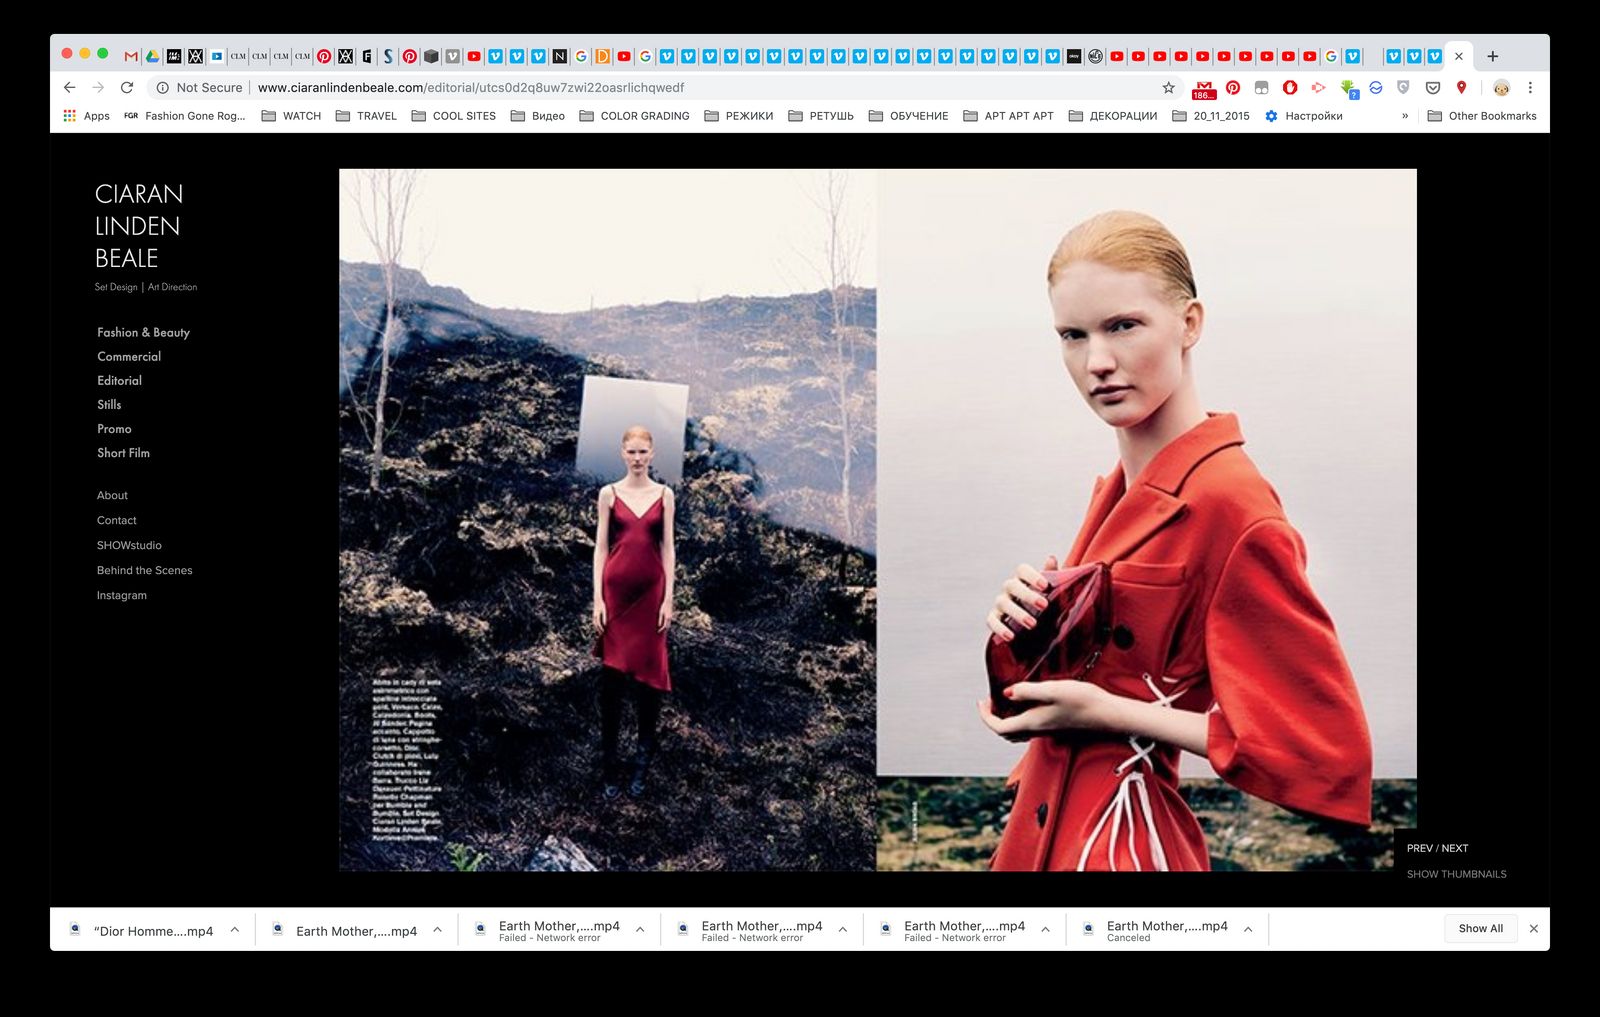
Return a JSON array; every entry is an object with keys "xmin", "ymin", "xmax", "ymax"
[{"xmin": 978, "ymin": 211, "xmax": 1371, "ymax": 871}]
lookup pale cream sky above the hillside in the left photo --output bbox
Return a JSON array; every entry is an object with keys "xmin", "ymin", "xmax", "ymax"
[{"xmin": 339, "ymin": 167, "xmax": 877, "ymax": 312}]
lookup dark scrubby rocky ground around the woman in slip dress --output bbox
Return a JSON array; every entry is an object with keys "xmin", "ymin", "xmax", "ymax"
[{"xmin": 339, "ymin": 307, "xmax": 875, "ymax": 870}]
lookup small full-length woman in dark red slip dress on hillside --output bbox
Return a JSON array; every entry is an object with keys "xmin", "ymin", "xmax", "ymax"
[{"xmin": 594, "ymin": 427, "xmax": 675, "ymax": 798}]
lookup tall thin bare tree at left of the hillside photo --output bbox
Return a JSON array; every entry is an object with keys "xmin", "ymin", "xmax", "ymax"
[{"xmin": 346, "ymin": 170, "xmax": 422, "ymax": 491}]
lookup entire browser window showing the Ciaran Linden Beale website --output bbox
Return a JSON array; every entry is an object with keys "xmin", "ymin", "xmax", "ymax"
[{"xmin": 46, "ymin": 32, "xmax": 1552, "ymax": 953}]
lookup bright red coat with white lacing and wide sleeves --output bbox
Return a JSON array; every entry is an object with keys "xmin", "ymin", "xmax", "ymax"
[{"xmin": 990, "ymin": 414, "xmax": 1373, "ymax": 871}]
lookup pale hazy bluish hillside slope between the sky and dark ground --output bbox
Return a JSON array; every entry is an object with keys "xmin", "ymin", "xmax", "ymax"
[{"xmin": 339, "ymin": 262, "xmax": 877, "ymax": 552}]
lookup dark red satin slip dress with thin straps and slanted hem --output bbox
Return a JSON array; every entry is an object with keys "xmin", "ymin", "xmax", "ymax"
[{"xmin": 595, "ymin": 488, "xmax": 672, "ymax": 692}]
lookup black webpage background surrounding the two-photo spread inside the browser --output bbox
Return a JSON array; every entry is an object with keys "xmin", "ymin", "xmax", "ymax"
[{"xmin": 48, "ymin": 133, "xmax": 1552, "ymax": 907}]
